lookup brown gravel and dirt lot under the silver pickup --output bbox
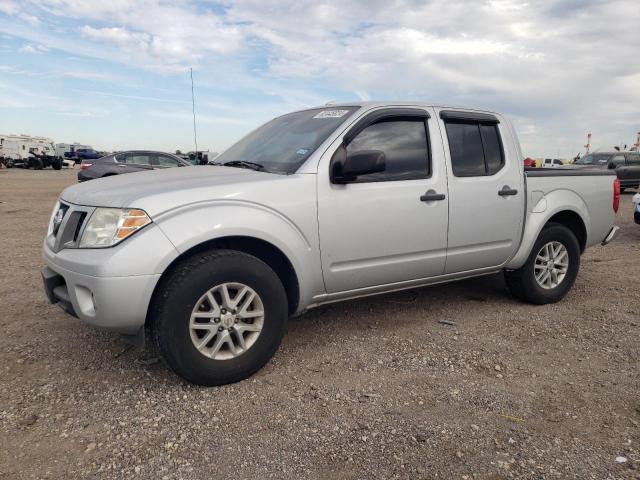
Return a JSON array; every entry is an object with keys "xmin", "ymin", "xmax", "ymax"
[{"xmin": 0, "ymin": 169, "xmax": 640, "ymax": 479}]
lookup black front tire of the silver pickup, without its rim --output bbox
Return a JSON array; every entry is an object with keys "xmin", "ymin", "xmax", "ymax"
[{"xmin": 150, "ymin": 249, "xmax": 288, "ymax": 386}]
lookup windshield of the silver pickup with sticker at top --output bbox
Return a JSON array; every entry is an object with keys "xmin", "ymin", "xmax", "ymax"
[{"xmin": 215, "ymin": 107, "xmax": 358, "ymax": 174}]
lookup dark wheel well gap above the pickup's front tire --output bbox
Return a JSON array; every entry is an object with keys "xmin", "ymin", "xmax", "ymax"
[{"xmin": 152, "ymin": 236, "xmax": 300, "ymax": 315}]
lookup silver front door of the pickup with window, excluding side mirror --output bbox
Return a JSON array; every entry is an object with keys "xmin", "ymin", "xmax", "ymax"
[{"xmin": 317, "ymin": 108, "xmax": 448, "ymax": 293}]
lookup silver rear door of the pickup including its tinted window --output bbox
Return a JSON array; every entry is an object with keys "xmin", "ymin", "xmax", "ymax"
[{"xmin": 439, "ymin": 110, "xmax": 525, "ymax": 273}]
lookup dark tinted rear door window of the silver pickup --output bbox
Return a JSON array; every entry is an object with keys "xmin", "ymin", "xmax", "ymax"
[{"xmin": 445, "ymin": 120, "xmax": 504, "ymax": 177}]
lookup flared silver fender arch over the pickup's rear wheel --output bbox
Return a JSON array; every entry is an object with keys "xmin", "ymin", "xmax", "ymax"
[{"xmin": 505, "ymin": 189, "xmax": 591, "ymax": 270}]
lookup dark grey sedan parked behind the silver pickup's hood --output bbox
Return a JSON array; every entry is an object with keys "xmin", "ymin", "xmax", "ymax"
[{"xmin": 78, "ymin": 150, "xmax": 191, "ymax": 182}]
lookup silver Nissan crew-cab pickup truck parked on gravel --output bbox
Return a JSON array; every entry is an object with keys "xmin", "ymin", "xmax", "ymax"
[{"xmin": 43, "ymin": 102, "xmax": 619, "ymax": 385}]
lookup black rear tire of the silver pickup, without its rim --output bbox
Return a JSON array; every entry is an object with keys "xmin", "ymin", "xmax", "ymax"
[{"xmin": 505, "ymin": 223, "xmax": 580, "ymax": 305}]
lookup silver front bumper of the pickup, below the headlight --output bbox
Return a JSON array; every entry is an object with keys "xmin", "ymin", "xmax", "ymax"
[{"xmin": 42, "ymin": 218, "xmax": 177, "ymax": 335}]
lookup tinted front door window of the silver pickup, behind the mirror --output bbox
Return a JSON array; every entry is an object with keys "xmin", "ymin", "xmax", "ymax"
[{"xmin": 347, "ymin": 118, "xmax": 431, "ymax": 183}]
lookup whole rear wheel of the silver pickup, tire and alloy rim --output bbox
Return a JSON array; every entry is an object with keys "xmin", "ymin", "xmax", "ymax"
[{"xmin": 505, "ymin": 223, "xmax": 580, "ymax": 305}]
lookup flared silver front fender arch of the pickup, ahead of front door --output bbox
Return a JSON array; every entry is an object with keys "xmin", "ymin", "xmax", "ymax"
[{"xmin": 154, "ymin": 199, "xmax": 324, "ymax": 307}]
